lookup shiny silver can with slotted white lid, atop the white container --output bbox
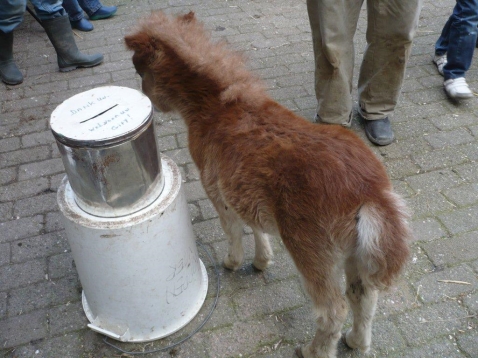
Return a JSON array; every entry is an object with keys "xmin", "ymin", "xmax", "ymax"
[{"xmin": 50, "ymin": 86, "xmax": 164, "ymax": 217}]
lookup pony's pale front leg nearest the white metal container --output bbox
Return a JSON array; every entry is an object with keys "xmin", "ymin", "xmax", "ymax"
[{"xmin": 216, "ymin": 205, "xmax": 244, "ymax": 271}]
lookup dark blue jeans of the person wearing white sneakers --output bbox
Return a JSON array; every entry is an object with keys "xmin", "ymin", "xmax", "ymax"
[{"xmin": 435, "ymin": 0, "xmax": 478, "ymax": 81}]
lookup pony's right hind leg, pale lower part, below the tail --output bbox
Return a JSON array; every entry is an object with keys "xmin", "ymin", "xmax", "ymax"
[{"xmin": 344, "ymin": 258, "xmax": 378, "ymax": 353}]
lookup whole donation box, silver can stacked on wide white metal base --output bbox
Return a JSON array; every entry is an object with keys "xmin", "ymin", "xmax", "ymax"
[{"xmin": 50, "ymin": 86, "xmax": 208, "ymax": 342}]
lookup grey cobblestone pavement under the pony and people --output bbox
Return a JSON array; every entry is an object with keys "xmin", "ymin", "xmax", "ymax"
[{"xmin": 0, "ymin": 0, "xmax": 478, "ymax": 358}]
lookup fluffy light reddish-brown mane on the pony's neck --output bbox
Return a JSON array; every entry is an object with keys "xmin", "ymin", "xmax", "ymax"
[{"xmin": 133, "ymin": 12, "xmax": 264, "ymax": 102}]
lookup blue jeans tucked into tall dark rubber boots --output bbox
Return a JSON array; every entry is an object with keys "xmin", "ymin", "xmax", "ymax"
[{"xmin": 0, "ymin": 0, "xmax": 66, "ymax": 33}]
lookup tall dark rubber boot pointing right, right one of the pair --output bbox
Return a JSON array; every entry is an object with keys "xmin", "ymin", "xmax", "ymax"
[{"xmin": 42, "ymin": 15, "xmax": 103, "ymax": 72}]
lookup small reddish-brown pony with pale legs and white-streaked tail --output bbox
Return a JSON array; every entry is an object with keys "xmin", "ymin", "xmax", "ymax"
[{"xmin": 125, "ymin": 12, "xmax": 411, "ymax": 358}]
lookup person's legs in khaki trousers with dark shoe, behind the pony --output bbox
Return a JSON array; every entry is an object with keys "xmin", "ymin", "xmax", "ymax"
[{"xmin": 307, "ymin": 0, "xmax": 421, "ymax": 145}]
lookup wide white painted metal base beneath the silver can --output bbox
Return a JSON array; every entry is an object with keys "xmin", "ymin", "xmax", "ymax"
[{"xmin": 58, "ymin": 156, "xmax": 208, "ymax": 342}]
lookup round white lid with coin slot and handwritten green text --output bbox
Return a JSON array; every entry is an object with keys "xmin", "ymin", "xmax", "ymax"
[{"xmin": 50, "ymin": 86, "xmax": 153, "ymax": 147}]
